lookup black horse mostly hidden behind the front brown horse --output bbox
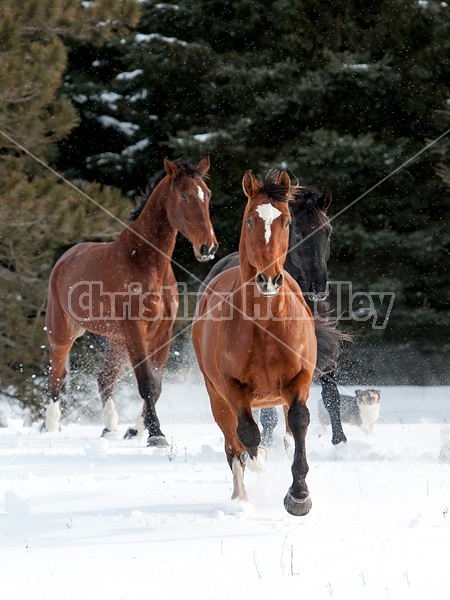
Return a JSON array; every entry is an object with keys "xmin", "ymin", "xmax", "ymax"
[{"xmin": 198, "ymin": 187, "xmax": 350, "ymax": 445}]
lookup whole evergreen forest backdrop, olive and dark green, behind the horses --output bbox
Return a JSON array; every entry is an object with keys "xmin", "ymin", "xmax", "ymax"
[{"xmin": 0, "ymin": 0, "xmax": 450, "ymax": 408}]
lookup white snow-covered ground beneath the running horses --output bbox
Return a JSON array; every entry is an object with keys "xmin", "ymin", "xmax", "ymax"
[{"xmin": 0, "ymin": 380, "xmax": 450, "ymax": 600}]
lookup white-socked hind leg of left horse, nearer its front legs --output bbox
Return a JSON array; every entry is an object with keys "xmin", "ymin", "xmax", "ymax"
[{"xmin": 98, "ymin": 342, "xmax": 127, "ymax": 435}]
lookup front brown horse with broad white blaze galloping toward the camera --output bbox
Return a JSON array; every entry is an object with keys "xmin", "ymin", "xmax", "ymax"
[{"xmin": 192, "ymin": 170, "xmax": 317, "ymax": 515}]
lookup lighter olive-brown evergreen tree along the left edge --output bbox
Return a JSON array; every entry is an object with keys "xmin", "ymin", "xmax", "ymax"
[{"xmin": 0, "ymin": 0, "xmax": 140, "ymax": 410}]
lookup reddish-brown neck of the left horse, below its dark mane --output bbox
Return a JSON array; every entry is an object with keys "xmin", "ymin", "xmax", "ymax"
[{"xmin": 117, "ymin": 177, "xmax": 177, "ymax": 270}]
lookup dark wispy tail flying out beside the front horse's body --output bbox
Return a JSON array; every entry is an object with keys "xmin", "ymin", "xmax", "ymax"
[{"xmin": 314, "ymin": 315, "xmax": 353, "ymax": 377}]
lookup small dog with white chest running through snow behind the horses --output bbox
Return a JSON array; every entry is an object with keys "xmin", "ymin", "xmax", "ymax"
[{"xmin": 319, "ymin": 389, "xmax": 380, "ymax": 433}]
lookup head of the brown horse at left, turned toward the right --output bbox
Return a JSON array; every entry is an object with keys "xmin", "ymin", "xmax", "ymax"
[{"xmin": 164, "ymin": 155, "xmax": 218, "ymax": 262}]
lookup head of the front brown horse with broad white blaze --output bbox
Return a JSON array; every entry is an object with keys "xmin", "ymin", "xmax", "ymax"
[{"xmin": 240, "ymin": 169, "xmax": 295, "ymax": 296}]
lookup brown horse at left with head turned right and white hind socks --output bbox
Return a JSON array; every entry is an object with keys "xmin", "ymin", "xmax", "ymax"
[{"xmin": 46, "ymin": 156, "xmax": 217, "ymax": 446}]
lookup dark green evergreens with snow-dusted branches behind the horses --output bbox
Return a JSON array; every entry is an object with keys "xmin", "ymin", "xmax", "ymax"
[{"xmin": 60, "ymin": 0, "xmax": 450, "ymax": 350}]
